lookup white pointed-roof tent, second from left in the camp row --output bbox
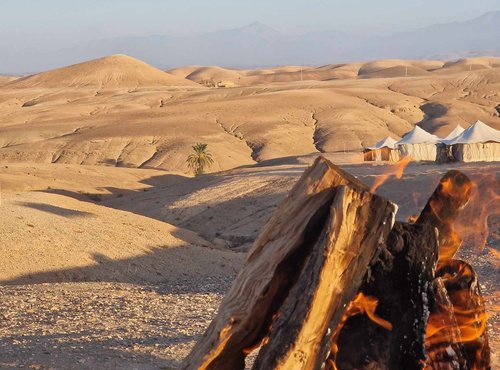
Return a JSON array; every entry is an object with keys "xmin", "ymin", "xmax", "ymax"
[{"xmin": 396, "ymin": 126, "xmax": 439, "ymax": 161}]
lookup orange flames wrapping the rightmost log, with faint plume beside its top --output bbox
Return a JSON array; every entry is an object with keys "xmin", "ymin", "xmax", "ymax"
[{"xmin": 418, "ymin": 171, "xmax": 492, "ymax": 369}]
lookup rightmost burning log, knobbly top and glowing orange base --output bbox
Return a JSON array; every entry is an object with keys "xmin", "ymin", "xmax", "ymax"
[{"xmin": 416, "ymin": 171, "xmax": 490, "ymax": 369}]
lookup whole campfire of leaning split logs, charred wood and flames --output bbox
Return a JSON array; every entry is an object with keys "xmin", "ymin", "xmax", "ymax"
[{"xmin": 183, "ymin": 158, "xmax": 490, "ymax": 370}]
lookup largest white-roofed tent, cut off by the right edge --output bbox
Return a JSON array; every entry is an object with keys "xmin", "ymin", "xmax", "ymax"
[{"xmin": 438, "ymin": 121, "xmax": 500, "ymax": 162}]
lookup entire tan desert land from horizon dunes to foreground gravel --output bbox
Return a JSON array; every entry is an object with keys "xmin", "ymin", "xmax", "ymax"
[{"xmin": 0, "ymin": 50, "xmax": 500, "ymax": 369}]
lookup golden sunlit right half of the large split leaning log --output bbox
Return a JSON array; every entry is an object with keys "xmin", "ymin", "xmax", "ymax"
[{"xmin": 254, "ymin": 187, "xmax": 395, "ymax": 370}]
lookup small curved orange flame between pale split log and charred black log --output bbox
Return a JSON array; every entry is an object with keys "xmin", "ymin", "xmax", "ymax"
[{"xmin": 326, "ymin": 292, "xmax": 392, "ymax": 370}]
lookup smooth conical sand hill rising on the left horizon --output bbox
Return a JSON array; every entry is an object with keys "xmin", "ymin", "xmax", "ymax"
[{"xmin": 9, "ymin": 55, "xmax": 194, "ymax": 88}]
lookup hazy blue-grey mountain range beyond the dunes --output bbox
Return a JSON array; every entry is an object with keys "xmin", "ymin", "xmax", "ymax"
[{"xmin": 0, "ymin": 11, "xmax": 500, "ymax": 72}]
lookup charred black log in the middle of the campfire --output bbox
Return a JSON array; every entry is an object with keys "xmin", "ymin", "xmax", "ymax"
[{"xmin": 329, "ymin": 222, "xmax": 438, "ymax": 370}]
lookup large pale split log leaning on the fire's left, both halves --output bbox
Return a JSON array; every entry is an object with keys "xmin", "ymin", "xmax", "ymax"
[{"xmin": 182, "ymin": 158, "xmax": 396, "ymax": 370}]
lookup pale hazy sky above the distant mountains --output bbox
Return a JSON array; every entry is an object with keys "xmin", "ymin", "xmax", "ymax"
[{"xmin": 0, "ymin": 0, "xmax": 500, "ymax": 50}]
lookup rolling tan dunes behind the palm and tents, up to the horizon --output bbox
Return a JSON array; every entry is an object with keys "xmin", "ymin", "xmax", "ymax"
[{"xmin": 0, "ymin": 56, "xmax": 500, "ymax": 173}]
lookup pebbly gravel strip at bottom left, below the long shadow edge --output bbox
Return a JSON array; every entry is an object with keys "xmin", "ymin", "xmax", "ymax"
[{"xmin": 0, "ymin": 278, "xmax": 231, "ymax": 369}]
